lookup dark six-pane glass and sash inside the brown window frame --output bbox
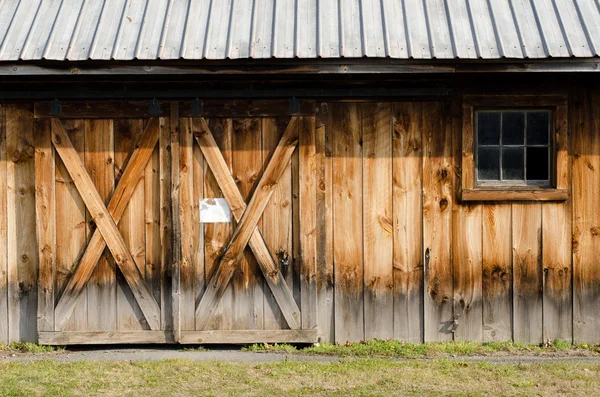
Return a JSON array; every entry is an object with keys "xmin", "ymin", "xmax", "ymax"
[{"xmin": 475, "ymin": 109, "xmax": 552, "ymax": 187}]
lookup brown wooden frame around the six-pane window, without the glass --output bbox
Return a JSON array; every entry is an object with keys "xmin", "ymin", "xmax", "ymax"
[{"xmin": 460, "ymin": 95, "xmax": 570, "ymax": 201}]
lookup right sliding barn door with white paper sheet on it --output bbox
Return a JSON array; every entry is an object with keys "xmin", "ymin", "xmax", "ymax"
[{"xmin": 174, "ymin": 110, "xmax": 316, "ymax": 343}]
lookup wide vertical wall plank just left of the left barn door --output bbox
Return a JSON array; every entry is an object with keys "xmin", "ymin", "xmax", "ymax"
[{"xmin": 6, "ymin": 105, "xmax": 38, "ymax": 342}]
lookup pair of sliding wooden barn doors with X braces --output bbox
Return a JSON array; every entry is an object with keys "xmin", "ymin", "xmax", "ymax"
[{"xmin": 34, "ymin": 101, "xmax": 316, "ymax": 344}]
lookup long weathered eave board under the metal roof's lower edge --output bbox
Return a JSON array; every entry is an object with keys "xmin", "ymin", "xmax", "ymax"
[{"xmin": 0, "ymin": 57, "xmax": 600, "ymax": 76}]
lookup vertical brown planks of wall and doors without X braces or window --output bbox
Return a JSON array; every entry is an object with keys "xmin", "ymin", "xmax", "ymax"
[{"xmin": 0, "ymin": 88, "xmax": 600, "ymax": 343}]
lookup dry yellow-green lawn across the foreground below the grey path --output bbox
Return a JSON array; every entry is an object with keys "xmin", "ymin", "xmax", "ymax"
[{"xmin": 0, "ymin": 358, "xmax": 600, "ymax": 397}]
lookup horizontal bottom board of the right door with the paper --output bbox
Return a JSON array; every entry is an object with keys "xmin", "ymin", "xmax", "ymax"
[{"xmin": 180, "ymin": 329, "xmax": 317, "ymax": 344}]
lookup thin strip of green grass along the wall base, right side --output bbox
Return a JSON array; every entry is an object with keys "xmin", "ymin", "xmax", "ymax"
[{"xmin": 244, "ymin": 339, "xmax": 600, "ymax": 358}]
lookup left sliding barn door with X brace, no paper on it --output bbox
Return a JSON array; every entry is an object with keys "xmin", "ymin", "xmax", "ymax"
[{"xmin": 32, "ymin": 102, "xmax": 172, "ymax": 344}]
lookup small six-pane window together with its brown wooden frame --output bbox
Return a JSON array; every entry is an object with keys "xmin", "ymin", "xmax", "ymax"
[{"xmin": 461, "ymin": 95, "xmax": 570, "ymax": 201}]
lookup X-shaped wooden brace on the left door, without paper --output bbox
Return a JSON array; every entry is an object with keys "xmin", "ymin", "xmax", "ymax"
[{"xmin": 52, "ymin": 118, "xmax": 160, "ymax": 330}]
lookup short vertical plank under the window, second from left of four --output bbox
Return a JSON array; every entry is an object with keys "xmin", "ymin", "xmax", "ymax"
[{"xmin": 482, "ymin": 204, "xmax": 513, "ymax": 342}]
